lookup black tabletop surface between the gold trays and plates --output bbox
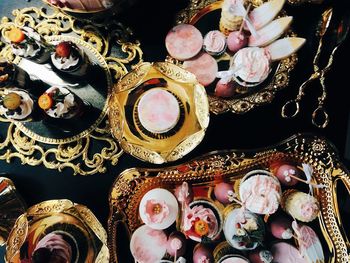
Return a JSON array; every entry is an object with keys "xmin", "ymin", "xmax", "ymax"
[{"xmin": 0, "ymin": 0, "xmax": 350, "ymax": 261}]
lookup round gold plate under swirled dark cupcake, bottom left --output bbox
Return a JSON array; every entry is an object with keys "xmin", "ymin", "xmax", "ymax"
[{"xmin": 5, "ymin": 199, "xmax": 109, "ymax": 263}]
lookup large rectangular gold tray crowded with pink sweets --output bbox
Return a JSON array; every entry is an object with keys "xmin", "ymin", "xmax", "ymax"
[{"xmin": 108, "ymin": 134, "xmax": 350, "ymax": 263}]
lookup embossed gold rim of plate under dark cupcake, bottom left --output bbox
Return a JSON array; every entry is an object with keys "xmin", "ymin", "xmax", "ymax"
[{"xmin": 5, "ymin": 199, "xmax": 109, "ymax": 263}]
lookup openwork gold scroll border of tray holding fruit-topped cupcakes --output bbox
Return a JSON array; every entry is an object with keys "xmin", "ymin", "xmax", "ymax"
[{"xmin": 0, "ymin": 7, "xmax": 142, "ymax": 175}]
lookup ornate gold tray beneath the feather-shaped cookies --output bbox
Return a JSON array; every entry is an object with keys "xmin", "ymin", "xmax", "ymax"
[{"xmin": 176, "ymin": 0, "xmax": 297, "ymax": 114}]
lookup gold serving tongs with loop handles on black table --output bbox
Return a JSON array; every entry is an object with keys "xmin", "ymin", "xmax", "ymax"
[{"xmin": 281, "ymin": 7, "xmax": 350, "ymax": 128}]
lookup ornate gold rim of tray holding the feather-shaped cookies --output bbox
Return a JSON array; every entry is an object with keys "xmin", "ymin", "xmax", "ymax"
[{"xmin": 176, "ymin": 0, "xmax": 297, "ymax": 114}]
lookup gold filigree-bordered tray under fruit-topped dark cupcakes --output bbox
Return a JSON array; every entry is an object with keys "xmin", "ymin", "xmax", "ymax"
[{"xmin": 0, "ymin": 7, "xmax": 142, "ymax": 175}]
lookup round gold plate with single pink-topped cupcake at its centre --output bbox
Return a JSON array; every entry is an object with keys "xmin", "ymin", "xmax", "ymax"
[{"xmin": 109, "ymin": 62, "xmax": 209, "ymax": 164}]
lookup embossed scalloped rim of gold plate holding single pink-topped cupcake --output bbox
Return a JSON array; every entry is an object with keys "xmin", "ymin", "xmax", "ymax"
[{"xmin": 108, "ymin": 62, "xmax": 209, "ymax": 164}]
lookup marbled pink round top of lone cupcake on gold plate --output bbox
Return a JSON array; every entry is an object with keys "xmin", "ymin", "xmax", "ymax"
[{"xmin": 137, "ymin": 88, "xmax": 180, "ymax": 133}]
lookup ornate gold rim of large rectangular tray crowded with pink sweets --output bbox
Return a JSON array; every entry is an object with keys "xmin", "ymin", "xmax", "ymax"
[{"xmin": 108, "ymin": 134, "xmax": 350, "ymax": 263}]
